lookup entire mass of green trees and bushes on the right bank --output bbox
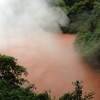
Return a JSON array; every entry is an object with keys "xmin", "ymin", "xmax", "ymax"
[{"xmin": 59, "ymin": 0, "xmax": 100, "ymax": 66}]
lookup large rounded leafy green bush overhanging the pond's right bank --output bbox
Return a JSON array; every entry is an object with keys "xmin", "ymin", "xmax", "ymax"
[{"xmin": 75, "ymin": 1, "xmax": 100, "ymax": 67}]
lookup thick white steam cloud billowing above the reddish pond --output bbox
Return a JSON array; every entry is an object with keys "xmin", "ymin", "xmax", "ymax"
[{"xmin": 0, "ymin": 0, "xmax": 68, "ymax": 36}]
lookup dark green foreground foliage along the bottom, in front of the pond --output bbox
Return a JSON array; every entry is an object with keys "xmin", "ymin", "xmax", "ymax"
[{"xmin": 0, "ymin": 55, "xmax": 94, "ymax": 100}]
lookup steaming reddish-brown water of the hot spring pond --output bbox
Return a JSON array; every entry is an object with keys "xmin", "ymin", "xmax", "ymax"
[{"xmin": 0, "ymin": 35, "xmax": 100, "ymax": 100}]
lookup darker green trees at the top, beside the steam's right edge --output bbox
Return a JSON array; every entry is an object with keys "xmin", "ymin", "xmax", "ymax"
[{"xmin": 58, "ymin": 0, "xmax": 94, "ymax": 33}]
